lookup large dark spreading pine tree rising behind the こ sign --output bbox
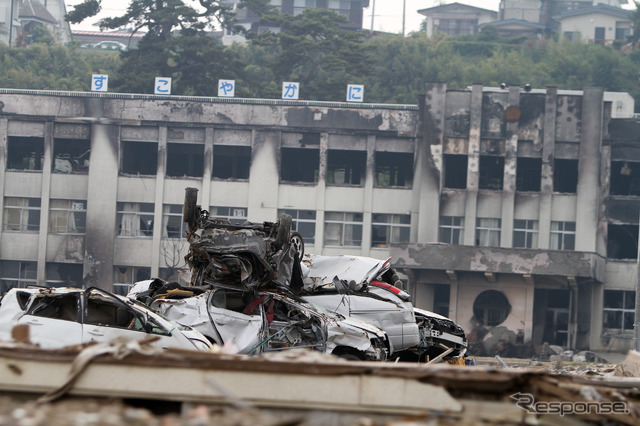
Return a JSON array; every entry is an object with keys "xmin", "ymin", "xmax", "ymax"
[{"xmin": 68, "ymin": 0, "xmax": 239, "ymax": 96}]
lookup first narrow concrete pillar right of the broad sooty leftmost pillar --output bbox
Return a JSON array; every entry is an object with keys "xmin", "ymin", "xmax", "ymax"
[{"xmin": 151, "ymin": 126, "xmax": 167, "ymax": 277}]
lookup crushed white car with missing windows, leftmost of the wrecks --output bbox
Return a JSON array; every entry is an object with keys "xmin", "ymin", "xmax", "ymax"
[{"xmin": 0, "ymin": 287, "xmax": 211, "ymax": 351}]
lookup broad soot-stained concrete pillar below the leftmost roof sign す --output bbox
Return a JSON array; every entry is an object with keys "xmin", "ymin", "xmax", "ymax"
[{"xmin": 83, "ymin": 98, "xmax": 120, "ymax": 290}]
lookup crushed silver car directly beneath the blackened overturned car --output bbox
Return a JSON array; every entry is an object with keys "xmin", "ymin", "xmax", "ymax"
[{"xmin": 128, "ymin": 279, "xmax": 388, "ymax": 361}]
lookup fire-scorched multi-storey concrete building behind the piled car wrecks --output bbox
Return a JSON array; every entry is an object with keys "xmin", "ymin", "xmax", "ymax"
[{"xmin": 0, "ymin": 83, "xmax": 640, "ymax": 354}]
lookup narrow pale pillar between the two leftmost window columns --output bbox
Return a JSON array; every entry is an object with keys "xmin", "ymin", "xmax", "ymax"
[{"xmin": 36, "ymin": 121, "xmax": 53, "ymax": 285}]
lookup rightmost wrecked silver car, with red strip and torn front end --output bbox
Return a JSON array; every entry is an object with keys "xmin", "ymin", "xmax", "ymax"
[{"xmin": 302, "ymin": 254, "xmax": 467, "ymax": 361}]
